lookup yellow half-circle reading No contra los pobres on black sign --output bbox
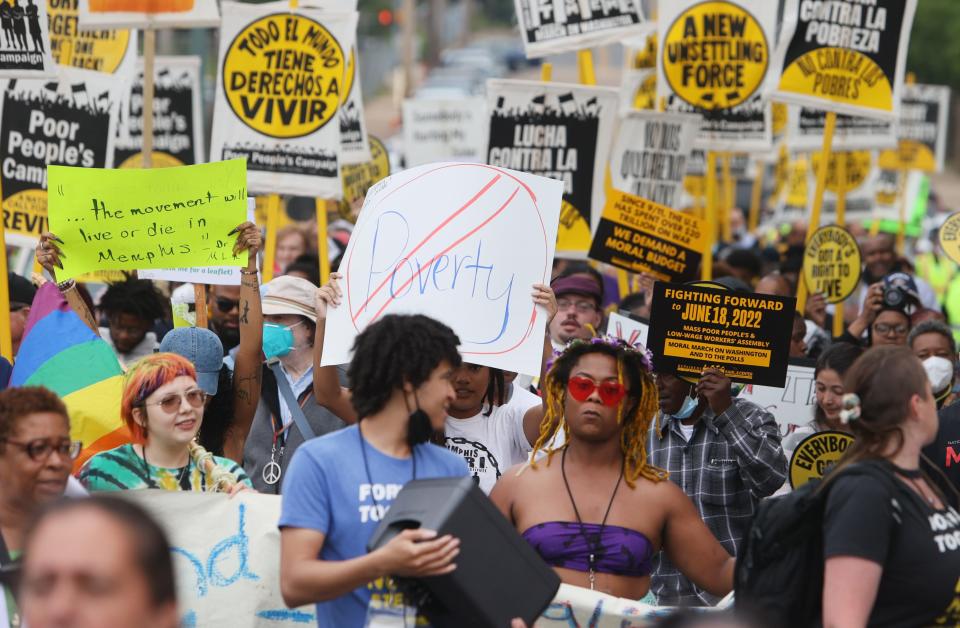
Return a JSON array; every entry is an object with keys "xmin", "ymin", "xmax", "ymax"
[{"xmin": 779, "ymin": 48, "xmax": 893, "ymax": 112}]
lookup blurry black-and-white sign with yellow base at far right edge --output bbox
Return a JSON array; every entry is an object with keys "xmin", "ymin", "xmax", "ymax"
[{"xmin": 880, "ymin": 85, "xmax": 950, "ymax": 172}]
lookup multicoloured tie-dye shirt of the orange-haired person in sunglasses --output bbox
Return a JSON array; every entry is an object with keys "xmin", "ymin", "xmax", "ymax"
[{"xmin": 80, "ymin": 444, "xmax": 253, "ymax": 492}]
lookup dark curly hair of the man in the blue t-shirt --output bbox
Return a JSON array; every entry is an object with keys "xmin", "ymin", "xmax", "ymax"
[{"xmin": 347, "ymin": 314, "xmax": 461, "ymax": 418}]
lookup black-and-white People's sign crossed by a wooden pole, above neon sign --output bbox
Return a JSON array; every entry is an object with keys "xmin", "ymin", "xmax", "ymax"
[{"xmin": 114, "ymin": 57, "xmax": 204, "ymax": 168}]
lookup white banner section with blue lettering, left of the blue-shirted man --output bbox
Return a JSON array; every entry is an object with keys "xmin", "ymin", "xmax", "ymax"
[{"xmin": 118, "ymin": 491, "xmax": 317, "ymax": 628}]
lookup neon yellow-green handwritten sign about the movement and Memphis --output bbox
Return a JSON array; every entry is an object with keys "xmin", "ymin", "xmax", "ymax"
[{"xmin": 47, "ymin": 159, "xmax": 247, "ymax": 279}]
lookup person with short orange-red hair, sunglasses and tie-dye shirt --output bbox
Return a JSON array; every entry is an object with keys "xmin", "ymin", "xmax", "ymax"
[{"xmin": 80, "ymin": 353, "xmax": 252, "ymax": 495}]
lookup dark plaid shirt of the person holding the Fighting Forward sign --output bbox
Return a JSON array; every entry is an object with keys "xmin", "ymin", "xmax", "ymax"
[{"xmin": 647, "ymin": 399, "xmax": 787, "ymax": 606}]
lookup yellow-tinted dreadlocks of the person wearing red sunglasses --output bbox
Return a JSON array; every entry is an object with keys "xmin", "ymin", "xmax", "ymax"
[{"xmin": 530, "ymin": 338, "xmax": 668, "ymax": 488}]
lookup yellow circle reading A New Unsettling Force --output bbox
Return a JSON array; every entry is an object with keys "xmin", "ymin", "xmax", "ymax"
[{"xmin": 660, "ymin": 2, "xmax": 770, "ymax": 109}]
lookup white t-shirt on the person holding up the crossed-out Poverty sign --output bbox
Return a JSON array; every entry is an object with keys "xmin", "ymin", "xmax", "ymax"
[{"xmin": 444, "ymin": 388, "xmax": 540, "ymax": 495}]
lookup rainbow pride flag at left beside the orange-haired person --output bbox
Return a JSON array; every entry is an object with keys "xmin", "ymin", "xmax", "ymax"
[{"xmin": 10, "ymin": 282, "xmax": 131, "ymax": 469}]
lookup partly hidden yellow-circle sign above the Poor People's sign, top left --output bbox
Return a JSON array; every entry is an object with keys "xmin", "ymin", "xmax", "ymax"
[{"xmin": 46, "ymin": 0, "xmax": 137, "ymax": 76}]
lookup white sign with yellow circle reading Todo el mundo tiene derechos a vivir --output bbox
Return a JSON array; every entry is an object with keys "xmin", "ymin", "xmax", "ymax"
[{"xmin": 210, "ymin": 2, "xmax": 357, "ymax": 199}]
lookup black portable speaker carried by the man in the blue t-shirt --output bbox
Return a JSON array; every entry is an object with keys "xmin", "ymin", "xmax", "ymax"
[{"xmin": 367, "ymin": 477, "xmax": 560, "ymax": 628}]
